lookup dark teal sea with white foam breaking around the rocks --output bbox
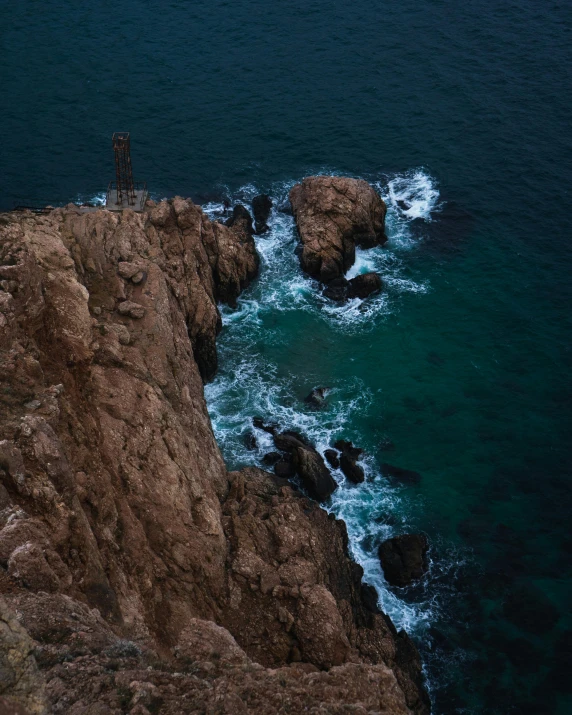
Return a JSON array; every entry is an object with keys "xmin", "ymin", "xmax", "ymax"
[{"xmin": 0, "ymin": 0, "xmax": 572, "ymax": 715}]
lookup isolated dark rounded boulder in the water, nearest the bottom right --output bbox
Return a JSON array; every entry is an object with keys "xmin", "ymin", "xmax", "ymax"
[{"xmin": 379, "ymin": 534, "xmax": 429, "ymax": 587}]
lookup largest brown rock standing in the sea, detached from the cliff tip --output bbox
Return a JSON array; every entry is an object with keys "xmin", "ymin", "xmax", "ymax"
[{"xmin": 290, "ymin": 176, "xmax": 387, "ymax": 283}]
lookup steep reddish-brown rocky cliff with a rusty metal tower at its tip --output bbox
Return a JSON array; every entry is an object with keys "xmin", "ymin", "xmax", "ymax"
[{"xmin": 0, "ymin": 198, "xmax": 428, "ymax": 715}]
